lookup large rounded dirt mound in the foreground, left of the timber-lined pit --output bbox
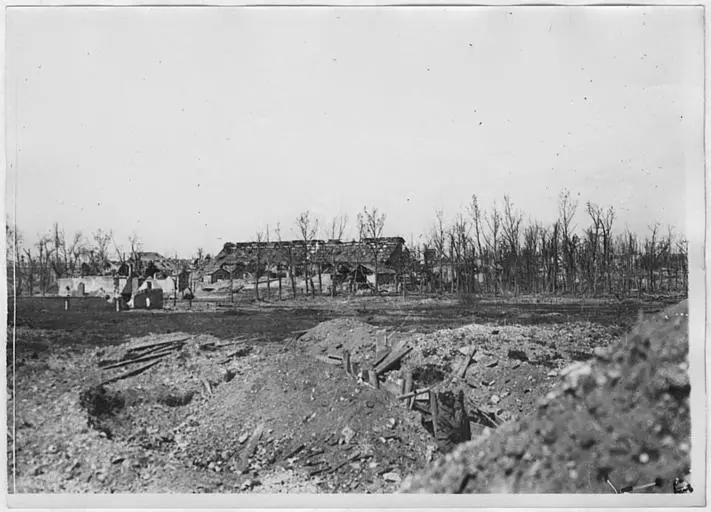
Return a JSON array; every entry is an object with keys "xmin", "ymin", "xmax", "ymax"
[{"xmin": 175, "ymin": 352, "xmax": 434, "ymax": 492}]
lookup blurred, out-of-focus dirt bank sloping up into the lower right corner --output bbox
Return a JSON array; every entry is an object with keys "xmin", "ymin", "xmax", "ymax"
[{"xmin": 403, "ymin": 301, "xmax": 690, "ymax": 493}]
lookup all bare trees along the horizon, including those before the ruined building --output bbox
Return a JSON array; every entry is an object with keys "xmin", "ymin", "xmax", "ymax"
[{"xmin": 6, "ymin": 190, "xmax": 688, "ymax": 298}]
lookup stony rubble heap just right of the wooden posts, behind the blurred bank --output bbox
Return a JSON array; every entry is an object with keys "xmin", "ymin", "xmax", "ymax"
[{"xmin": 402, "ymin": 322, "xmax": 614, "ymax": 426}]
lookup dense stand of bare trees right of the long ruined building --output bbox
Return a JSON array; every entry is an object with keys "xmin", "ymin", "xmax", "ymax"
[{"xmin": 418, "ymin": 190, "xmax": 688, "ymax": 295}]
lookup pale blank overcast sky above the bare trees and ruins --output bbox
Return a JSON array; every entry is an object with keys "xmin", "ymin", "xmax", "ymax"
[{"xmin": 6, "ymin": 7, "xmax": 703, "ymax": 257}]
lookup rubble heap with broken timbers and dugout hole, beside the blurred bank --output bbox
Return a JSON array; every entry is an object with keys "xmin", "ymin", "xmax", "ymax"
[{"xmin": 299, "ymin": 319, "xmax": 615, "ymax": 452}]
